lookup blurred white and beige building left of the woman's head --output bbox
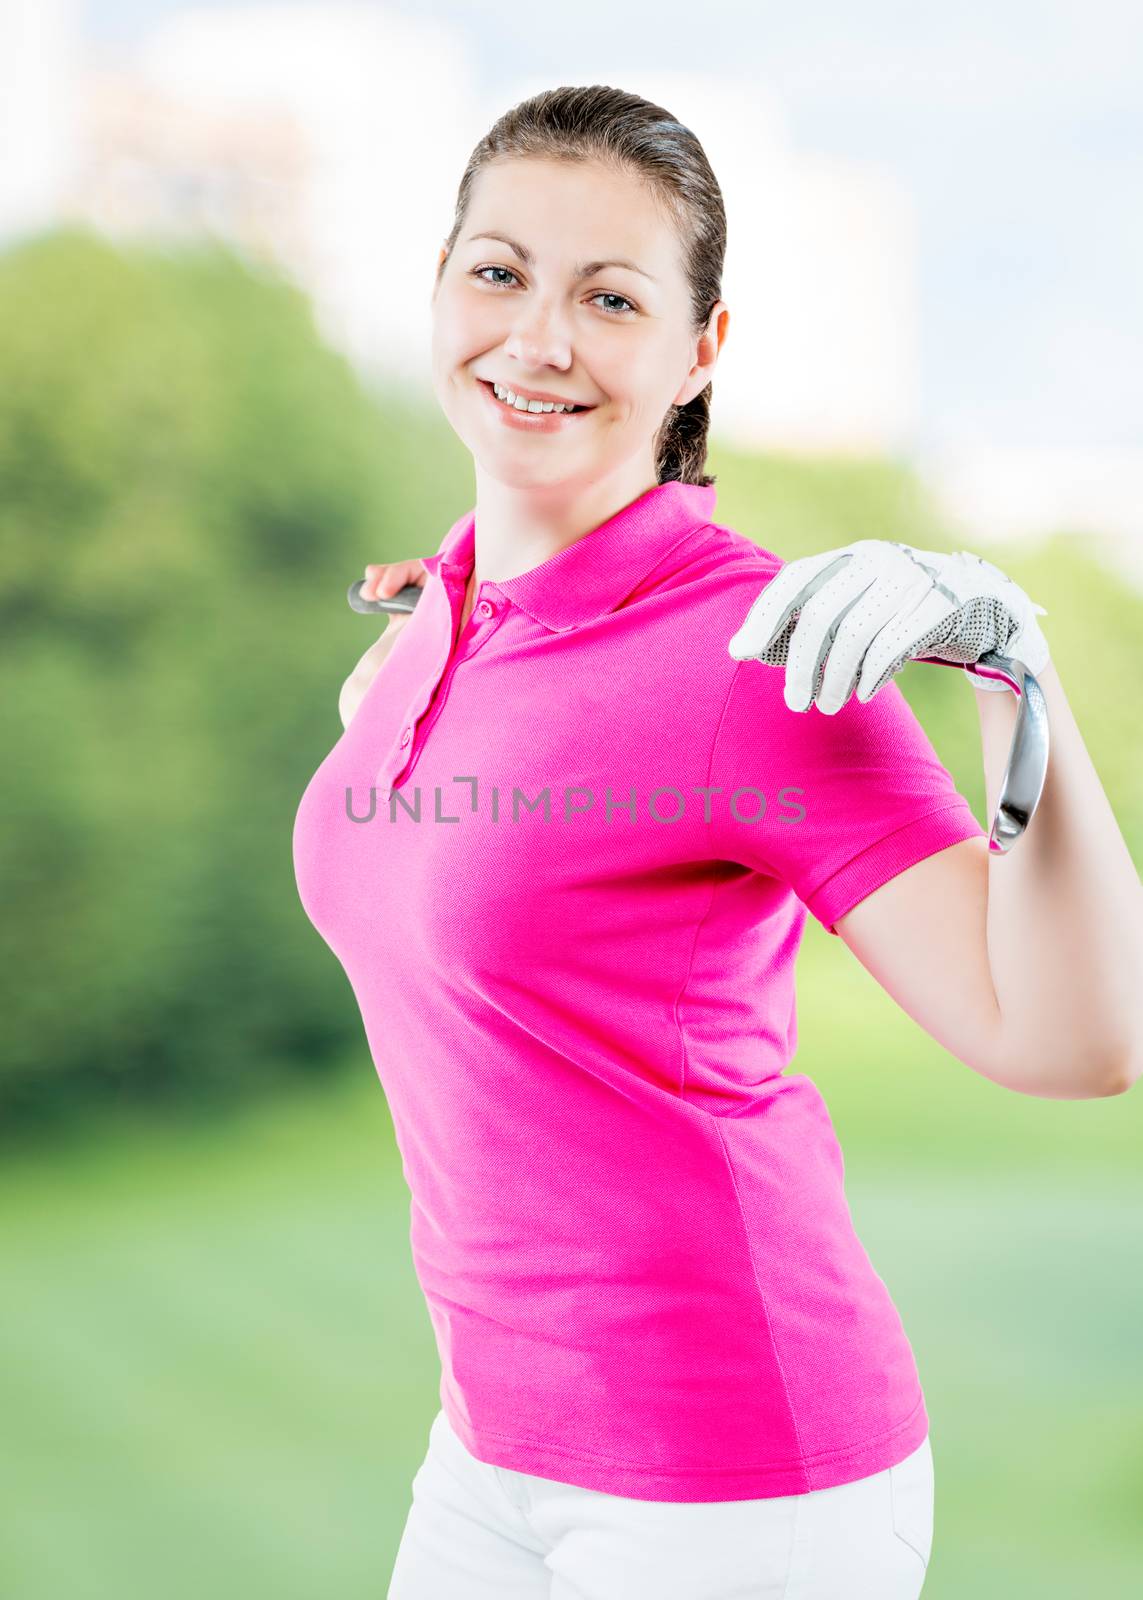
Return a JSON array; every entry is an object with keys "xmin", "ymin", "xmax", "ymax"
[{"xmin": 102, "ymin": 3, "xmax": 475, "ymax": 390}]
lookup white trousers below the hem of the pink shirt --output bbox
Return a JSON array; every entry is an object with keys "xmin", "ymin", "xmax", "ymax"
[{"xmin": 387, "ymin": 1411, "xmax": 933, "ymax": 1600}]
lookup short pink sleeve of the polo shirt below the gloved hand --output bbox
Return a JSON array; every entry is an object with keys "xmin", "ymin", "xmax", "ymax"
[{"xmin": 709, "ymin": 659, "xmax": 988, "ymax": 934}]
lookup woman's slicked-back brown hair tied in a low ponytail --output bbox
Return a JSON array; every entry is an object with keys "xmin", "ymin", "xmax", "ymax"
[{"xmin": 437, "ymin": 83, "xmax": 727, "ymax": 485}]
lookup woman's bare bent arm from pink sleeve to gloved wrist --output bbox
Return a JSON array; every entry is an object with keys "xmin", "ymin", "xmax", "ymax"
[{"xmin": 837, "ymin": 666, "xmax": 1143, "ymax": 1099}]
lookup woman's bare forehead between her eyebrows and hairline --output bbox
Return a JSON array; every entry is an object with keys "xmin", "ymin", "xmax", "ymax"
[{"xmin": 459, "ymin": 157, "xmax": 680, "ymax": 277}]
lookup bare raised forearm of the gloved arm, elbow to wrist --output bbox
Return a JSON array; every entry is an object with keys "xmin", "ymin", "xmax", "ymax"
[{"xmin": 977, "ymin": 664, "xmax": 1143, "ymax": 1099}]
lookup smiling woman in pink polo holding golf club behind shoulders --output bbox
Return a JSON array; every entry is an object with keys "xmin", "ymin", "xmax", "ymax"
[{"xmin": 295, "ymin": 86, "xmax": 1140, "ymax": 1600}]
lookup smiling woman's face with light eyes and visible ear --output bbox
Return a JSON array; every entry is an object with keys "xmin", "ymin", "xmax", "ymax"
[{"xmin": 432, "ymin": 158, "xmax": 728, "ymax": 488}]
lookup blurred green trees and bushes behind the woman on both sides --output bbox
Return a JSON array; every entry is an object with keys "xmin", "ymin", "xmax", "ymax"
[{"xmin": 0, "ymin": 229, "xmax": 1143, "ymax": 1152}]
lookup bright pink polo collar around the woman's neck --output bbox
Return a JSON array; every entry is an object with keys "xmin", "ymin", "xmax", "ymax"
[{"xmin": 423, "ymin": 478, "xmax": 717, "ymax": 632}]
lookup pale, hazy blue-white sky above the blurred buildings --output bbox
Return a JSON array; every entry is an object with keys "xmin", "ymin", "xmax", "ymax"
[{"xmin": 83, "ymin": 0, "xmax": 1143, "ymax": 448}]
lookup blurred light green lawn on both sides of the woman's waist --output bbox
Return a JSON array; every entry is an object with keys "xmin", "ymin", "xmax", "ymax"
[{"xmin": 0, "ymin": 930, "xmax": 1143, "ymax": 1600}]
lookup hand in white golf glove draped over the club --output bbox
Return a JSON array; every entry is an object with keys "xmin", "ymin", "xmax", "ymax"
[{"xmin": 728, "ymin": 539, "xmax": 1049, "ymax": 715}]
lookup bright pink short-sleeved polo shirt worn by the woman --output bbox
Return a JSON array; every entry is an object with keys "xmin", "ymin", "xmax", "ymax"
[{"xmin": 293, "ymin": 483, "xmax": 986, "ymax": 1501}]
